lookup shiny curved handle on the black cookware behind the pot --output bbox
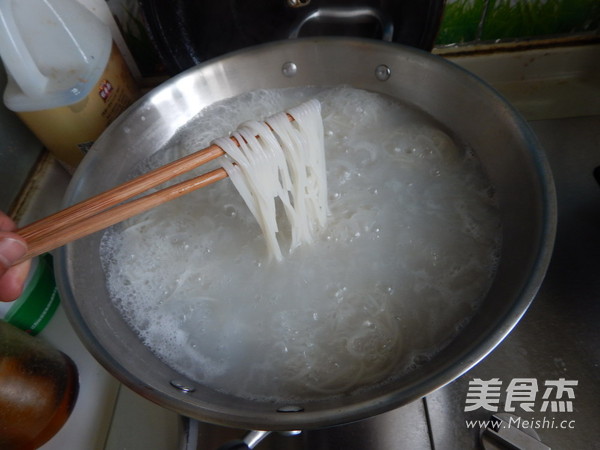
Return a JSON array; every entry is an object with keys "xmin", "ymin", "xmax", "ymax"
[{"xmin": 289, "ymin": 7, "xmax": 394, "ymax": 42}]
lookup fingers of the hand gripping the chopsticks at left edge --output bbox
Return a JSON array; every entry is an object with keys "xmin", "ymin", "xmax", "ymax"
[{"xmin": 0, "ymin": 211, "xmax": 31, "ymax": 302}]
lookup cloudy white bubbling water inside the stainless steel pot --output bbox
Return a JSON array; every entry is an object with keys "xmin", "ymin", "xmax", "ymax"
[{"xmin": 101, "ymin": 87, "xmax": 500, "ymax": 401}]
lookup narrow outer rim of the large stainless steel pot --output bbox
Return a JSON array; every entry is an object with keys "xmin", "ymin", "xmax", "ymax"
[{"xmin": 55, "ymin": 37, "xmax": 556, "ymax": 431}]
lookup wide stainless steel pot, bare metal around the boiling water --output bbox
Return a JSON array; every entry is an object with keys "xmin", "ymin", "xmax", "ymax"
[{"xmin": 56, "ymin": 38, "xmax": 556, "ymax": 430}]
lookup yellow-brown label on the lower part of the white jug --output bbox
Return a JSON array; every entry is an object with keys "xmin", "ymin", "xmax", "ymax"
[{"xmin": 17, "ymin": 43, "xmax": 139, "ymax": 172}]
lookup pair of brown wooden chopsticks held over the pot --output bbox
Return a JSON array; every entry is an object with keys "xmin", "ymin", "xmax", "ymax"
[{"xmin": 15, "ymin": 144, "xmax": 227, "ymax": 264}]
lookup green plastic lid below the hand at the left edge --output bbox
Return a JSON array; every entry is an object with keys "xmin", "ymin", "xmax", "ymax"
[{"xmin": 4, "ymin": 254, "xmax": 60, "ymax": 335}]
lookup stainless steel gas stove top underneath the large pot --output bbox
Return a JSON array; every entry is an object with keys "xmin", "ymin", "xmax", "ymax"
[{"xmin": 21, "ymin": 45, "xmax": 600, "ymax": 450}]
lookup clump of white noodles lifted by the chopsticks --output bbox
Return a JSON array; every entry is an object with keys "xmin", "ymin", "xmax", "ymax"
[{"xmin": 213, "ymin": 99, "xmax": 327, "ymax": 261}]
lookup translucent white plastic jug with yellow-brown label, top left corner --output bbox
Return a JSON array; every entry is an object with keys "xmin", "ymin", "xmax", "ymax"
[{"xmin": 0, "ymin": 0, "xmax": 138, "ymax": 169}]
